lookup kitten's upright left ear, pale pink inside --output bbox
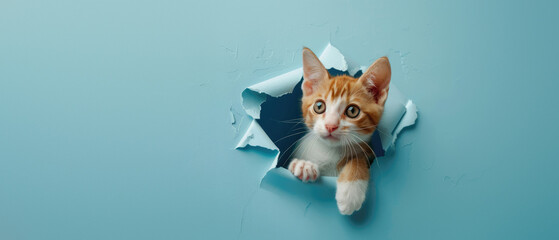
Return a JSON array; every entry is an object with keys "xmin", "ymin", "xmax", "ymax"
[{"xmin": 301, "ymin": 47, "xmax": 329, "ymax": 96}]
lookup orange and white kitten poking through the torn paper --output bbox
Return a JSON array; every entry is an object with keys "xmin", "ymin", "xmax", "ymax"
[{"xmin": 288, "ymin": 48, "xmax": 391, "ymax": 215}]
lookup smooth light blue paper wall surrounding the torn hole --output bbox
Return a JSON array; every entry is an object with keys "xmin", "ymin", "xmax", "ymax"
[{"xmin": 0, "ymin": 0, "xmax": 559, "ymax": 240}]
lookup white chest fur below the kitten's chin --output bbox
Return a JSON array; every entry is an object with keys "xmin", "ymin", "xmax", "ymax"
[{"xmin": 294, "ymin": 133, "xmax": 343, "ymax": 176}]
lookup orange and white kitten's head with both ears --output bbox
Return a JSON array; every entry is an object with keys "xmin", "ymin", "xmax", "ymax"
[{"xmin": 302, "ymin": 48, "xmax": 391, "ymax": 146}]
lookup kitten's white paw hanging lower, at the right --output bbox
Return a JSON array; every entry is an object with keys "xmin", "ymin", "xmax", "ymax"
[{"xmin": 336, "ymin": 180, "xmax": 368, "ymax": 215}]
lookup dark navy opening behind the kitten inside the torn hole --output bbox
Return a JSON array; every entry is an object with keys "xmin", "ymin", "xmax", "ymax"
[{"xmin": 257, "ymin": 68, "xmax": 384, "ymax": 168}]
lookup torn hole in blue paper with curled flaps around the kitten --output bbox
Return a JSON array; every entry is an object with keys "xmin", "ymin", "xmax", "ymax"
[{"xmin": 236, "ymin": 44, "xmax": 417, "ymax": 188}]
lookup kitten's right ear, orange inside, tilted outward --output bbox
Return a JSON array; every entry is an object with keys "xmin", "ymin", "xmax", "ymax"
[{"xmin": 359, "ymin": 57, "xmax": 392, "ymax": 105}]
